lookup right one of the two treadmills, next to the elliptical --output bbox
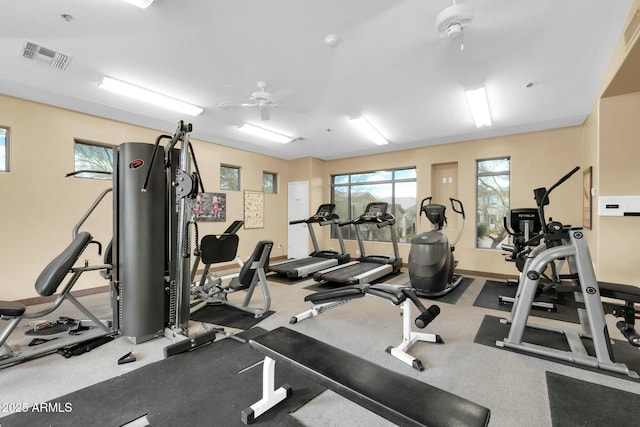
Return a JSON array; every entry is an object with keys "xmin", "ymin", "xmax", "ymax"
[{"xmin": 313, "ymin": 202, "xmax": 402, "ymax": 285}]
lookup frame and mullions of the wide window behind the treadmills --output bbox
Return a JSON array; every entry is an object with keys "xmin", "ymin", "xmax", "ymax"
[{"xmin": 330, "ymin": 166, "xmax": 418, "ymax": 244}]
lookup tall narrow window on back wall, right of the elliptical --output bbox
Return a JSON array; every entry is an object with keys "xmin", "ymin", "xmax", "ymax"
[{"xmin": 476, "ymin": 157, "xmax": 510, "ymax": 249}]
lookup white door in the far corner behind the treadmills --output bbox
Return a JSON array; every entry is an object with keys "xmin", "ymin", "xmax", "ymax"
[{"xmin": 287, "ymin": 181, "xmax": 309, "ymax": 258}]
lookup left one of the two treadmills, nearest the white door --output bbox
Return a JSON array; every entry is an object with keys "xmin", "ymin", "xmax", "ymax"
[{"xmin": 269, "ymin": 203, "xmax": 350, "ymax": 279}]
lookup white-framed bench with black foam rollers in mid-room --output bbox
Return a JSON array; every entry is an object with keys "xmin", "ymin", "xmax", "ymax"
[{"xmin": 289, "ymin": 283, "xmax": 444, "ymax": 372}]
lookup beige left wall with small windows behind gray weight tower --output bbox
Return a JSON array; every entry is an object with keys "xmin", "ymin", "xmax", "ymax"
[{"xmin": 0, "ymin": 95, "xmax": 289, "ymax": 300}]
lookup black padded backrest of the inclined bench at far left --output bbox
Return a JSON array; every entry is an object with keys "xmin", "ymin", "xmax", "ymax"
[{"xmin": 36, "ymin": 231, "xmax": 91, "ymax": 297}]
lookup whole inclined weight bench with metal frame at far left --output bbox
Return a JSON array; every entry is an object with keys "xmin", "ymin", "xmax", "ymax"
[{"xmin": 0, "ymin": 232, "xmax": 113, "ymax": 368}]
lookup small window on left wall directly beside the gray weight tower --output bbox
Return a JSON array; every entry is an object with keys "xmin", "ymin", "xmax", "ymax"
[{"xmin": 73, "ymin": 139, "xmax": 113, "ymax": 180}]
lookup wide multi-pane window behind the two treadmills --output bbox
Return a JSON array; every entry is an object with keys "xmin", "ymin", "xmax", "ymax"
[{"xmin": 331, "ymin": 168, "xmax": 416, "ymax": 243}]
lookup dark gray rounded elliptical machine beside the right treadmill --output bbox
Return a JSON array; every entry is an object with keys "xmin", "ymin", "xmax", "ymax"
[{"xmin": 409, "ymin": 197, "xmax": 465, "ymax": 297}]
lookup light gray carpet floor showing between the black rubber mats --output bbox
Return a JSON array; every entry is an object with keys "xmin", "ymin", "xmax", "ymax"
[{"xmin": 0, "ymin": 273, "xmax": 640, "ymax": 427}]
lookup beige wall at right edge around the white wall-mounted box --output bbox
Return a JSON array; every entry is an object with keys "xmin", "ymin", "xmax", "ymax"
[{"xmin": 584, "ymin": 0, "xmax": 640, "ymax": 286}]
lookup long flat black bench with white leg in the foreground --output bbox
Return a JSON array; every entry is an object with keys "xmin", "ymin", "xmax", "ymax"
[{"xmin": 241, "ymin": 327, "xmax": 491, "ymax": 426}]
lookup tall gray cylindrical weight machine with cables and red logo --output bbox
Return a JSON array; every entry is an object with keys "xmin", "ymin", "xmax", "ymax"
[{"xmin": 111, "ymin": 121, "xmax": 204, "ymax": 343}]
